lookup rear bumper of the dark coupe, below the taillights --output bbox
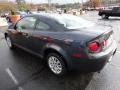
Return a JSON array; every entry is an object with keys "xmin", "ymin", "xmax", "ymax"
[{"xmin": 69, "ymin": 41, "xmax": 117, "ymax": 72}]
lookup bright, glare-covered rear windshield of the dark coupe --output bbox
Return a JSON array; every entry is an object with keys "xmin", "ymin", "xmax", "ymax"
[{"xmin": 54, "ymin": 15, "xmax": 94, "ymax": 30}]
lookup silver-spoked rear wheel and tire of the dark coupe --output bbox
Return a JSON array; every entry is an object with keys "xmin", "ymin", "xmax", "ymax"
[{"xmin": 47, "ymin": 53, "xmax": 66, "ymax": 76}]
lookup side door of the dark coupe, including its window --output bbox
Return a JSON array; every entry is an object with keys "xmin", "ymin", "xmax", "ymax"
[{"xmin": 15, "ymin": 16, "xmax": 37, "ymax": 49}]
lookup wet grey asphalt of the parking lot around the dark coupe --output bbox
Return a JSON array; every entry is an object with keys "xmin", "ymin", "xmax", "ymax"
[{"xmin": 0, "ymin": 12, "xmax": 120, "ymax": 90}]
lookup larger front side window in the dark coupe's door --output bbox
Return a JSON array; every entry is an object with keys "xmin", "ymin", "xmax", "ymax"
[{"xmin": 17, "ymin": 17, "xmax": 36, "ymax": 30}]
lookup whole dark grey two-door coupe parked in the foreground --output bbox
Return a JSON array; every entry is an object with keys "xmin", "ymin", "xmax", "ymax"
[{"xmin": 5, "ymin": 14, "xmax": 117, "ymax": 76}]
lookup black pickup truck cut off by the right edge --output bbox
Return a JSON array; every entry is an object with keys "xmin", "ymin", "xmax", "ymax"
[{"xmin": 98, "ymin": 7, "xmax": 120, "ymax": 19}]
